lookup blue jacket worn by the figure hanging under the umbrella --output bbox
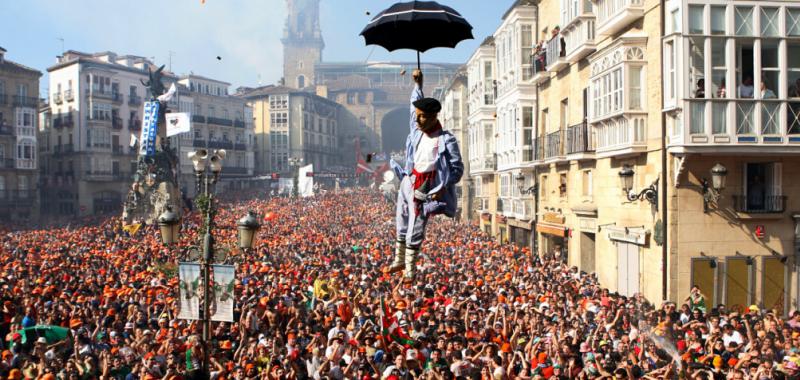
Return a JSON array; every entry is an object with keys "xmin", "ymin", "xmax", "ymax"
[{"xmin": 391, "ymin": 85, "xmax": 464, "ymax": 218}]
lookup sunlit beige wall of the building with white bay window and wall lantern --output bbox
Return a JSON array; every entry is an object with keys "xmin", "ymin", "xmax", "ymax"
[{"xmin": 534, "ymin": 0, "xmax": 663, "ymax": 301}]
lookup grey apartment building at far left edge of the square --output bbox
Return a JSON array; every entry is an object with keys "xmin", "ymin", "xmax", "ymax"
[{"xmin": 0, "ymin": 47, "xmax": 42, "ymax": 222}]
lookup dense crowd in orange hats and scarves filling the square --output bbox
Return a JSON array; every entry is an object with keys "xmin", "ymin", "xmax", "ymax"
[{"xmin": 0, "ymin": 190, "xmax": 800, "ymax": 380}]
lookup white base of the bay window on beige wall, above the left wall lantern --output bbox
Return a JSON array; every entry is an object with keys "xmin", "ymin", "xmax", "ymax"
[{"xmin": 591, "ymin": 112, "xmax": 647, "ymax": 158}]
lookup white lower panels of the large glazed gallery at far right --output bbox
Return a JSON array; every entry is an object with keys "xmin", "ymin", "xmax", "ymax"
[{"xmin": 667, "ymin": 99, "xmax": 800, "ymax": 154}]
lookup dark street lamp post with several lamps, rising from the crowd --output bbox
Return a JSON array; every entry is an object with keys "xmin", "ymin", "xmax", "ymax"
[{"xmin": 158, "ymin": 149, "xmax": 260, "ymax": 376}]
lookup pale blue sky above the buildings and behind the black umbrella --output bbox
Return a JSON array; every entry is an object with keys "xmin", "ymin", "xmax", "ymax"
[{"xmin": 0, "ymin": 0, "xmax": 512, "ymax": 93}]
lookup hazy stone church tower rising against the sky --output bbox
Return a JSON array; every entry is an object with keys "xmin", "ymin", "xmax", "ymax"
[{"xmin": 281, "ymin": 0, "xmax": 325, "ymax": 89}]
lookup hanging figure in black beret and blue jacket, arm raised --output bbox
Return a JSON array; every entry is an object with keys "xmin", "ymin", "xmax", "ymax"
[{"xmin": 384, "ymin": 70, "xmax": 464, "ymax": 284}]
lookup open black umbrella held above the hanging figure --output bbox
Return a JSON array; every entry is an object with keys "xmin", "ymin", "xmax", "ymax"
[{"xmin": 361, "ymin": 1, "xmax": 473, "ymax": 68}]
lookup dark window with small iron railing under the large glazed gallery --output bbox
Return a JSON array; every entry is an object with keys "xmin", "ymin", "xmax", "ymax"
[{"xmin": 740, "ymin": 162, "xmax": 783, "ymax": 212}]
